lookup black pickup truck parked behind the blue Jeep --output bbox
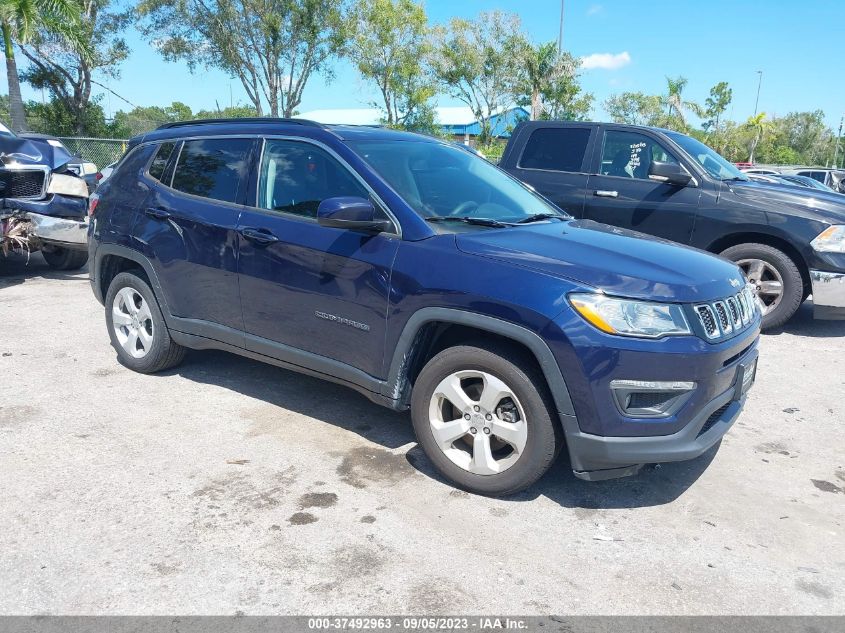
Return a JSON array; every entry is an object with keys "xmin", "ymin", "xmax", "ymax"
[{"xmin": 499, "ymin": 121, "xmax": 845, "ymax": 329}]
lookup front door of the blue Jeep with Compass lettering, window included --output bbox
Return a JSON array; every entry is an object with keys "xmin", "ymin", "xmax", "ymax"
[{"xmin": 238, "ymin": 139, "xmax": 400, "ymax": 377}]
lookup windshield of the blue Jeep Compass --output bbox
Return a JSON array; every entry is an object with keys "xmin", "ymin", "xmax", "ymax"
[{"xmin": 349, "ymin": 140, "xmax": 563, "ymax": 222}]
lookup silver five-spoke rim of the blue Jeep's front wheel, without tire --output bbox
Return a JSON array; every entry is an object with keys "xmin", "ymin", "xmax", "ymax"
[{"xmin": 429, "ymin": 370, "xmax": 528, "ymax": 475}]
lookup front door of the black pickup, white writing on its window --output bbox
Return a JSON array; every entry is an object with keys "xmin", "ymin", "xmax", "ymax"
[{"xmin": 584, "ymin": 127, "xmax": 701, "ymax": 244}]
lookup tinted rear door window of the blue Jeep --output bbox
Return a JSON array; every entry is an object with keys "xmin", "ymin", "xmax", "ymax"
[{"xmin": 173, "ymin": 138, "xmax": 252, "ymax": 202}]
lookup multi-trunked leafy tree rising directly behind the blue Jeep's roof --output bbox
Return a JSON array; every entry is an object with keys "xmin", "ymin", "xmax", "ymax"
[{"xmin": 139, "ymin": 0, "xmax": 344, "ymax": 117}]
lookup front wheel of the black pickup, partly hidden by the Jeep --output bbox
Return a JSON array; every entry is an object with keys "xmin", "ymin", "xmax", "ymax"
[{"xmin": 721, "ymin": 244, "xmax": 804, "ymax": 330}]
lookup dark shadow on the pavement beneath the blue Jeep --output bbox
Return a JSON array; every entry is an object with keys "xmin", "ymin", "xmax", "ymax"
[{"xmin": 162, "ymin": 350, "xmax": 718, "ymax": 509}]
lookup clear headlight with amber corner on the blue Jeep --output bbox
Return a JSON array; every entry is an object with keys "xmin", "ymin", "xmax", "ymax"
[{"xmin": 569, "ymin": 294, "xmax": 692, "ymax": 338}]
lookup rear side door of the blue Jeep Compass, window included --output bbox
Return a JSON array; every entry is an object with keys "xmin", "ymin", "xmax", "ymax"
[{"xmin": 135, "ymin": 137, "xmax": 256, "ymax": 336}]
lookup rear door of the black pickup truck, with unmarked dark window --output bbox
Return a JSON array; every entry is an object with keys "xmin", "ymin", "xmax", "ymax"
[{"xmin": 508, "ymin": 123, "xmax": 596, "ymax": 217}]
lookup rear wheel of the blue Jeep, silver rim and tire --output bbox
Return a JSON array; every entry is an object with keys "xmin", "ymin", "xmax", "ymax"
[{"xmin": 105, "ymin": 272, "xmax": 185, "ymax": 374}]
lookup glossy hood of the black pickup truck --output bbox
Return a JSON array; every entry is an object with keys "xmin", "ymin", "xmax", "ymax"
[{"xmin": 725, "ymin": 180, "xmax": 845, "ymax": 224}]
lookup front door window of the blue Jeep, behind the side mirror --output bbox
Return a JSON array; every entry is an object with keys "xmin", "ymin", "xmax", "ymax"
[{"xmin": 258, "ymin": 139, "xmax": 370, "ymax": 218}]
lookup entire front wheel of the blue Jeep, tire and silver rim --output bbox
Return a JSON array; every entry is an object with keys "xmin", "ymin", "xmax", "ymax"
[{"xmin": 411, "ymin": 345, "xmax": 562, "ymax": 496}]
